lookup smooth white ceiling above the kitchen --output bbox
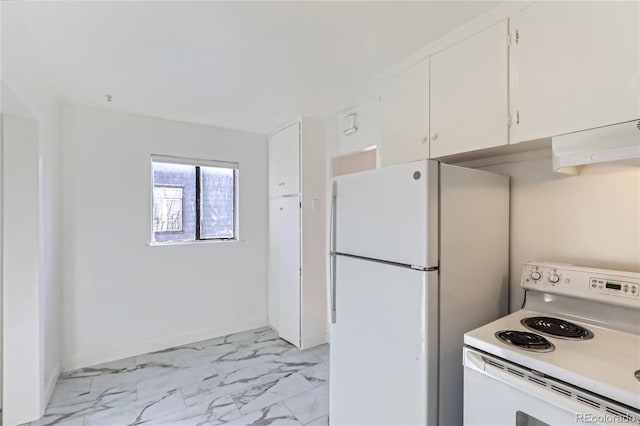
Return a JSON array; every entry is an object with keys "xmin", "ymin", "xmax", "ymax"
[{"xmin": 11, "ymin": 1, "xmax": 497, "ymax": 133}]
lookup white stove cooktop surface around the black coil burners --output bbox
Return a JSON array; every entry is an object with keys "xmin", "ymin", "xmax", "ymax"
[{"xmin": 464, "ymin": 309, "xmax": 640, "ymax": 410}]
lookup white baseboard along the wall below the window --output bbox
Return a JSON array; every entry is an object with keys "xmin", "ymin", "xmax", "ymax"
[{"xmin": 62, "ymin": 317, "xmax": 268, "ymax": 371}]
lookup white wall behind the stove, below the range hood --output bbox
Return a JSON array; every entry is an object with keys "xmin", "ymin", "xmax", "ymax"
[{"xmin": 485, "ymin": 158, "xmax": 640, "ymax": 310}]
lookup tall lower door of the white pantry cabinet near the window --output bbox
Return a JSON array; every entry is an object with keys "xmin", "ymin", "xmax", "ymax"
[{"xmin": 270, "ymin": 197, "xmax": 300, "ymax": 347}]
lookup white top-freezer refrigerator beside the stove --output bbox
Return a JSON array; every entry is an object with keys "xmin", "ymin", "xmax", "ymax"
[{"xmin": 329, "ymin": 160, "xmax": 509, "ymax": 426}]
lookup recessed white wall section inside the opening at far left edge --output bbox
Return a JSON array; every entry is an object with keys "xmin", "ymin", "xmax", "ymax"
[{"xmin": 2, "ymin": 114, "xmax": 42, "ymax": 425}]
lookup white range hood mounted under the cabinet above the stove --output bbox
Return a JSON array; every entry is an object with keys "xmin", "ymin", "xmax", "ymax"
[{"xmin": 551, "ymin": 120, "xmax": 640, "ymax": 174}]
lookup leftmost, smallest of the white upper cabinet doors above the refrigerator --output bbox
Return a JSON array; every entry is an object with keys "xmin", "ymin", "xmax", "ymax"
[{"xmin": 379, "ymin": 60, "xmax": 429, "ymax": 166}]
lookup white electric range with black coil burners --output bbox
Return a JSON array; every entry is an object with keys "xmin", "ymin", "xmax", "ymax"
[{"xmin": 463, "ymin": 262, "xmax": 640, "ymax": 426}]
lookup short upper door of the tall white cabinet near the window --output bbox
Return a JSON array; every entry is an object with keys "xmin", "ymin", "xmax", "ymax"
[{"xmin": 269, "ymin": 123, "xmax": 300, "ymax": 196}]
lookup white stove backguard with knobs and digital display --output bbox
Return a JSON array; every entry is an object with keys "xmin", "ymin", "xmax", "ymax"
[{"xmin": 520, "ymin": 262, "xmax": 640, "ymax": 309}]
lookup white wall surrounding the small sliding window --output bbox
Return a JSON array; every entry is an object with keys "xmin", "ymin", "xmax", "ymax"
[{"xmin": 63, "ymin": 106, "xmax": 267, "ymax": 369}]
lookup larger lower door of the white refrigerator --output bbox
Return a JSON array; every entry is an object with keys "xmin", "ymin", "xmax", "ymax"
[{"xmin": 329, "ymin": 256, "xmax": 438, "ymax": 426}]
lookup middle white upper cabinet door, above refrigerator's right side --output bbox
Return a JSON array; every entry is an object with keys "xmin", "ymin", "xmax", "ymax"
[{"xmin": 430, "ymin": 20, "xmax": 509, "ymax": 158}]
